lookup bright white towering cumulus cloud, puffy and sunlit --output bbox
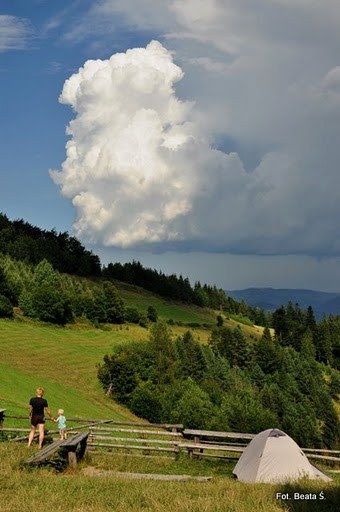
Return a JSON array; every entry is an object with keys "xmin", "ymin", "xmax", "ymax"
[{"xmin": 51, "ymin": 41, "xmax": 245, "ymax": 247}]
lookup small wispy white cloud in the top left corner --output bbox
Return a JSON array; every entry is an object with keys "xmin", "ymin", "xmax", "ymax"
[{"xmin": 0, "ymin": 14, "xmax": 31, "ymax": 52}]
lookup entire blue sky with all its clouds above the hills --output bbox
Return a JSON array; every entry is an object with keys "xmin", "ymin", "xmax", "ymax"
[{"xmin": 0, "ymin": 0, "xmax": 340, "ymax": 291}]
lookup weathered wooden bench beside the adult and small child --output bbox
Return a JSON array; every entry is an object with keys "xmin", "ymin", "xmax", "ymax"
[{"xmin": 25, "ymin": 432, "xmax": 89, "ymax": 467}]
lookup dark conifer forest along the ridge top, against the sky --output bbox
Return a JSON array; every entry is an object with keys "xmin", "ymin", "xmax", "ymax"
[{"xmin": 0, "ymin": 214, "xmax": 266, "ymax": 325}]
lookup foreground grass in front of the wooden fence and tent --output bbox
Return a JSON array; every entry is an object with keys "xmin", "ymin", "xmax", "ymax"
[{"xmin": 0, "ymin": 443, "xmax": 339, "ymax": 512}]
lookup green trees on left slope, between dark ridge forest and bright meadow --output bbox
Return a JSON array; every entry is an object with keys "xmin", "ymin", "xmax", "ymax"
[{"xmin": 0, "ymin": 257, "xmax": 158, "ymax": 327}]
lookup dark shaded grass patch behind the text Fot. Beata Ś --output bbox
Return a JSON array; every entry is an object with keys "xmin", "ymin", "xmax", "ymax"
[{"xmin": 276, "ymin": 483, "xmax": 340, "ymax": 512}]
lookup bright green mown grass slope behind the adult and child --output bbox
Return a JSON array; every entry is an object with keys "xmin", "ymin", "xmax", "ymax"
[{"xmin": 0, "ymin": 320, "xmax": 146, "ymax": 420}]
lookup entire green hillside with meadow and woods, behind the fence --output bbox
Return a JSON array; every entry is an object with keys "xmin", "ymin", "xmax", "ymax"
[{"xmin": 0, "ymin": 216, "xmax": 340, "ymax": 448}]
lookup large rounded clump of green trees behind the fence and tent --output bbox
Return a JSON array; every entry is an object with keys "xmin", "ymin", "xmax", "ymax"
[{"xmin": 98, "ymin": 322, "xmax": 340, "ymax": 448}]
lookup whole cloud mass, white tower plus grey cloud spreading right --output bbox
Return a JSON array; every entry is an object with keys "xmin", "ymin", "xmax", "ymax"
[{"xmin": 53, "ymin": 0, "xmax": 340, "ymax": 255}]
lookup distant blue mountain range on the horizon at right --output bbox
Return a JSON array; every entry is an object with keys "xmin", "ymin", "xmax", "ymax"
[{"xmin": 226, "ymin": 288, "xmax": 340, "ymax": 319}]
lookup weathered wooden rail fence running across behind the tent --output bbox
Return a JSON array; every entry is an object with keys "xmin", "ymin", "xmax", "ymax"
[{"xmin": 0, "ymin": 410, "xmax": 340, "ymax": 463}]
